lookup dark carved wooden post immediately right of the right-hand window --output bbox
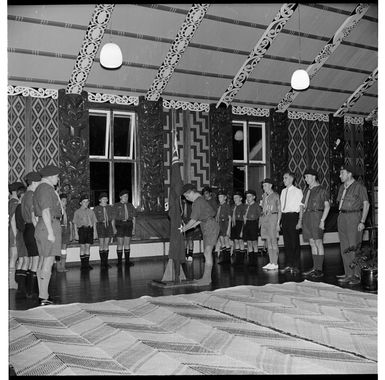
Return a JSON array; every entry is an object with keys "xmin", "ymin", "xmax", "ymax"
[{"xmin": 270, "ymin": 109, "xmax": 289, "ymax": 193}]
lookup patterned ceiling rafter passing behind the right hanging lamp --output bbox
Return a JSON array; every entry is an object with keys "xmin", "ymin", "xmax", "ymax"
[{"xmin": 277, "ymin": 3, "xmax": 369, "ymax": 112}]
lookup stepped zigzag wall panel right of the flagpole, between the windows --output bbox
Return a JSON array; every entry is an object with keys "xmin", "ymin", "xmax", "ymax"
[{"xmin": 187, "ymin": 111, "xmax": 210, "ymax": 190}]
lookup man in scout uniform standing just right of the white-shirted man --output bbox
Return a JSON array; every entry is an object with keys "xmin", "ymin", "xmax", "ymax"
[{"xmin": 299, "ymin": 168, "xmax": 330, "ymax": 279}]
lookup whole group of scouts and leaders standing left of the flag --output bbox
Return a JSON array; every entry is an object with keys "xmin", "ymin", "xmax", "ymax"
[{"xmin": 8, "ymin": 165, "xmax": 136, "ymax": 305}]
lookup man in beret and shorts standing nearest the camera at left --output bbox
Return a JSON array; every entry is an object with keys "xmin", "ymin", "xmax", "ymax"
[{"xmin": 33, "ymin": 165, "xmax": 62, "ymax": 306}]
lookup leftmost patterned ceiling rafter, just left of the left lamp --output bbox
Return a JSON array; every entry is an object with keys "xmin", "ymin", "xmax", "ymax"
[{"xmin": 66, "ymin": 4, "xmax": 115, "ymax": 94}]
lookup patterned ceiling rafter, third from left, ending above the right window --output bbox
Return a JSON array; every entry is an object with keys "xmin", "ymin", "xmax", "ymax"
[{"xmin": 216, "ymin": 3, "xmax": 298, "ymax": 108}]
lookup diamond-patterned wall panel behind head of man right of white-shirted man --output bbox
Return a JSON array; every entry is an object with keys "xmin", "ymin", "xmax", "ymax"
[{"xmin": 307, "ymin": 121, "xmax": 330, "ymax": 192}]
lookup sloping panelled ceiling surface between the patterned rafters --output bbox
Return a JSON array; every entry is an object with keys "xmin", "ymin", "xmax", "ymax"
[{"xmin": 8, "ymin": 3, "xmax": 378, "ymax": 117}]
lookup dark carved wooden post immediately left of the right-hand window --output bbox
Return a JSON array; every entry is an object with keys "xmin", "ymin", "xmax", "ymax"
[{"xmin": 209, "ymin": 104, "xmax": 233, "ymax": 194}]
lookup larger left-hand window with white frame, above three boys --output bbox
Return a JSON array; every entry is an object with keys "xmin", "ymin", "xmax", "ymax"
[{"xmin": 89, "ymin": 110, "xmax": 139, "ymax": 207}]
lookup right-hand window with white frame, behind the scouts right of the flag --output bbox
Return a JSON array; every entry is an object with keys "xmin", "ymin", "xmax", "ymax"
[{"xmin": 233, "ymin": 120, "xmax": 266, "ymax": 198}]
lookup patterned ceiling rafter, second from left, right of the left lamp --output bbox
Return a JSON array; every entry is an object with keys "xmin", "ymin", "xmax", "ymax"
[{"xmin": 146, "ymin": 4, "xmax": 210, "ymax": 100}]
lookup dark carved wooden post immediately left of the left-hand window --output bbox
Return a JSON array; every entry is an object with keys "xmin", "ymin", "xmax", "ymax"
[{"xmin": 58, "ymin": 89, "xmax": 90, "ymax": 220}]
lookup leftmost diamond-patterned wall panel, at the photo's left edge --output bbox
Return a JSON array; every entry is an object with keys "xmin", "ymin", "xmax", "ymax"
[{"xmin": 8, "ymin": 96, "xmax": 26, "ymax": 183}]
